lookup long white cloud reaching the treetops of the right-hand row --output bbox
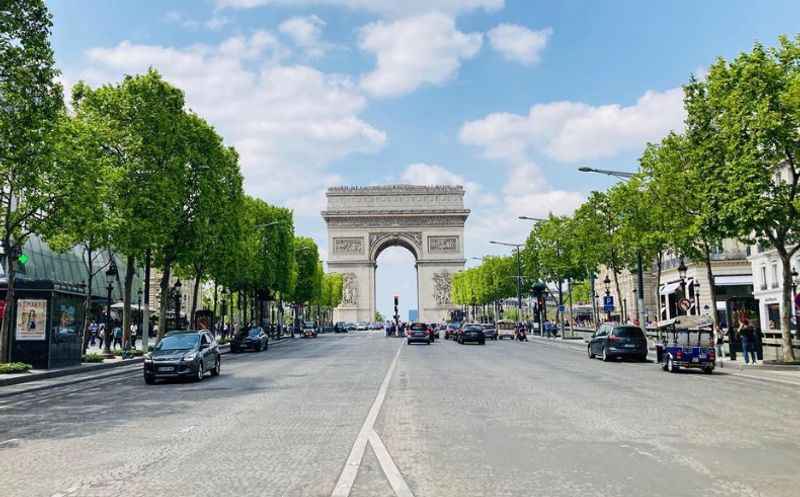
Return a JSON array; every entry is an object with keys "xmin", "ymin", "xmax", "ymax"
[{"xmin": 460, "ymin": 88, "xmax": 685, "ymax": 162}]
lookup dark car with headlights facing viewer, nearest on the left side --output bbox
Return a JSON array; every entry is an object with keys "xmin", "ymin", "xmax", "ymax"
[{"xmin": 143, "ymin": 330, "xmax": 222, "ymax": 385}]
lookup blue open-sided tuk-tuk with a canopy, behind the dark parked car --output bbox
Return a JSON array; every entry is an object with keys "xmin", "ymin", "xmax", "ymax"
[{"xmin": 656, "ymin": 316, "xmax": 717, "ymax": 374}]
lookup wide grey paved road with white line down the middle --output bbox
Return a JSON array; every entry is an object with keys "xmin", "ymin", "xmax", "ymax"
[{"xmin": 0, "ymin": 333, "xmax": 800, "ymax": 497}]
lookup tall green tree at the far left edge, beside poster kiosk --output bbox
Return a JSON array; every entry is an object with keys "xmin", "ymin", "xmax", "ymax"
[{"xmin": 0, "ymin": 0, "xmax": 69, "ymax": 361}]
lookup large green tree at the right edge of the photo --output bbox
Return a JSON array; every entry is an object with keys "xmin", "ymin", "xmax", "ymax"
[{"xmin": 704, "ymin": 36, "xmax": 800, "ymax": 361}]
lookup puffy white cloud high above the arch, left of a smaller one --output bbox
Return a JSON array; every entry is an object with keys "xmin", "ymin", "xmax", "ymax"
[{"xmin": 359, "ymin": 13, "xmax": 483, "ymax": 97}]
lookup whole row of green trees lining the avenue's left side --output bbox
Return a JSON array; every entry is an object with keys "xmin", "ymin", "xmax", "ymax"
[{"xmin": 0, "ymin": 0, "xmax": 341, "ymax": 361}]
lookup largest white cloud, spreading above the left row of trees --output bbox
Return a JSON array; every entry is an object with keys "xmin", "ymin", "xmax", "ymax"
[{"xmin": 76, "ymin": 32, "xmax": 386, "ymax": 203}]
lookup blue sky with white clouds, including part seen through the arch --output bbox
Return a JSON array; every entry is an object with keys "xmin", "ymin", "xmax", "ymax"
[{"xmin": 48, "ymin": 0, "xmax": 800, "ymax": 316}]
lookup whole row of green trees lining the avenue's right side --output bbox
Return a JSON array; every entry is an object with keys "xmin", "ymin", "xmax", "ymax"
[{"xmin": 462, "ymin": 36, "xmax": 800, "ymax": 360}]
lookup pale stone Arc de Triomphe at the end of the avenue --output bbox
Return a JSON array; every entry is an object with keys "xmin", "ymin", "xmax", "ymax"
[{"xmin": 322, "ymin": 185, "xmax": 469, "ymax": 322}]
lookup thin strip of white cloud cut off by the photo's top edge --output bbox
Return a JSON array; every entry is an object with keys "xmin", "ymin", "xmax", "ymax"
[{"xmin": 215, "ymin": 0, "xmax": 505, "ymax": 17}]
